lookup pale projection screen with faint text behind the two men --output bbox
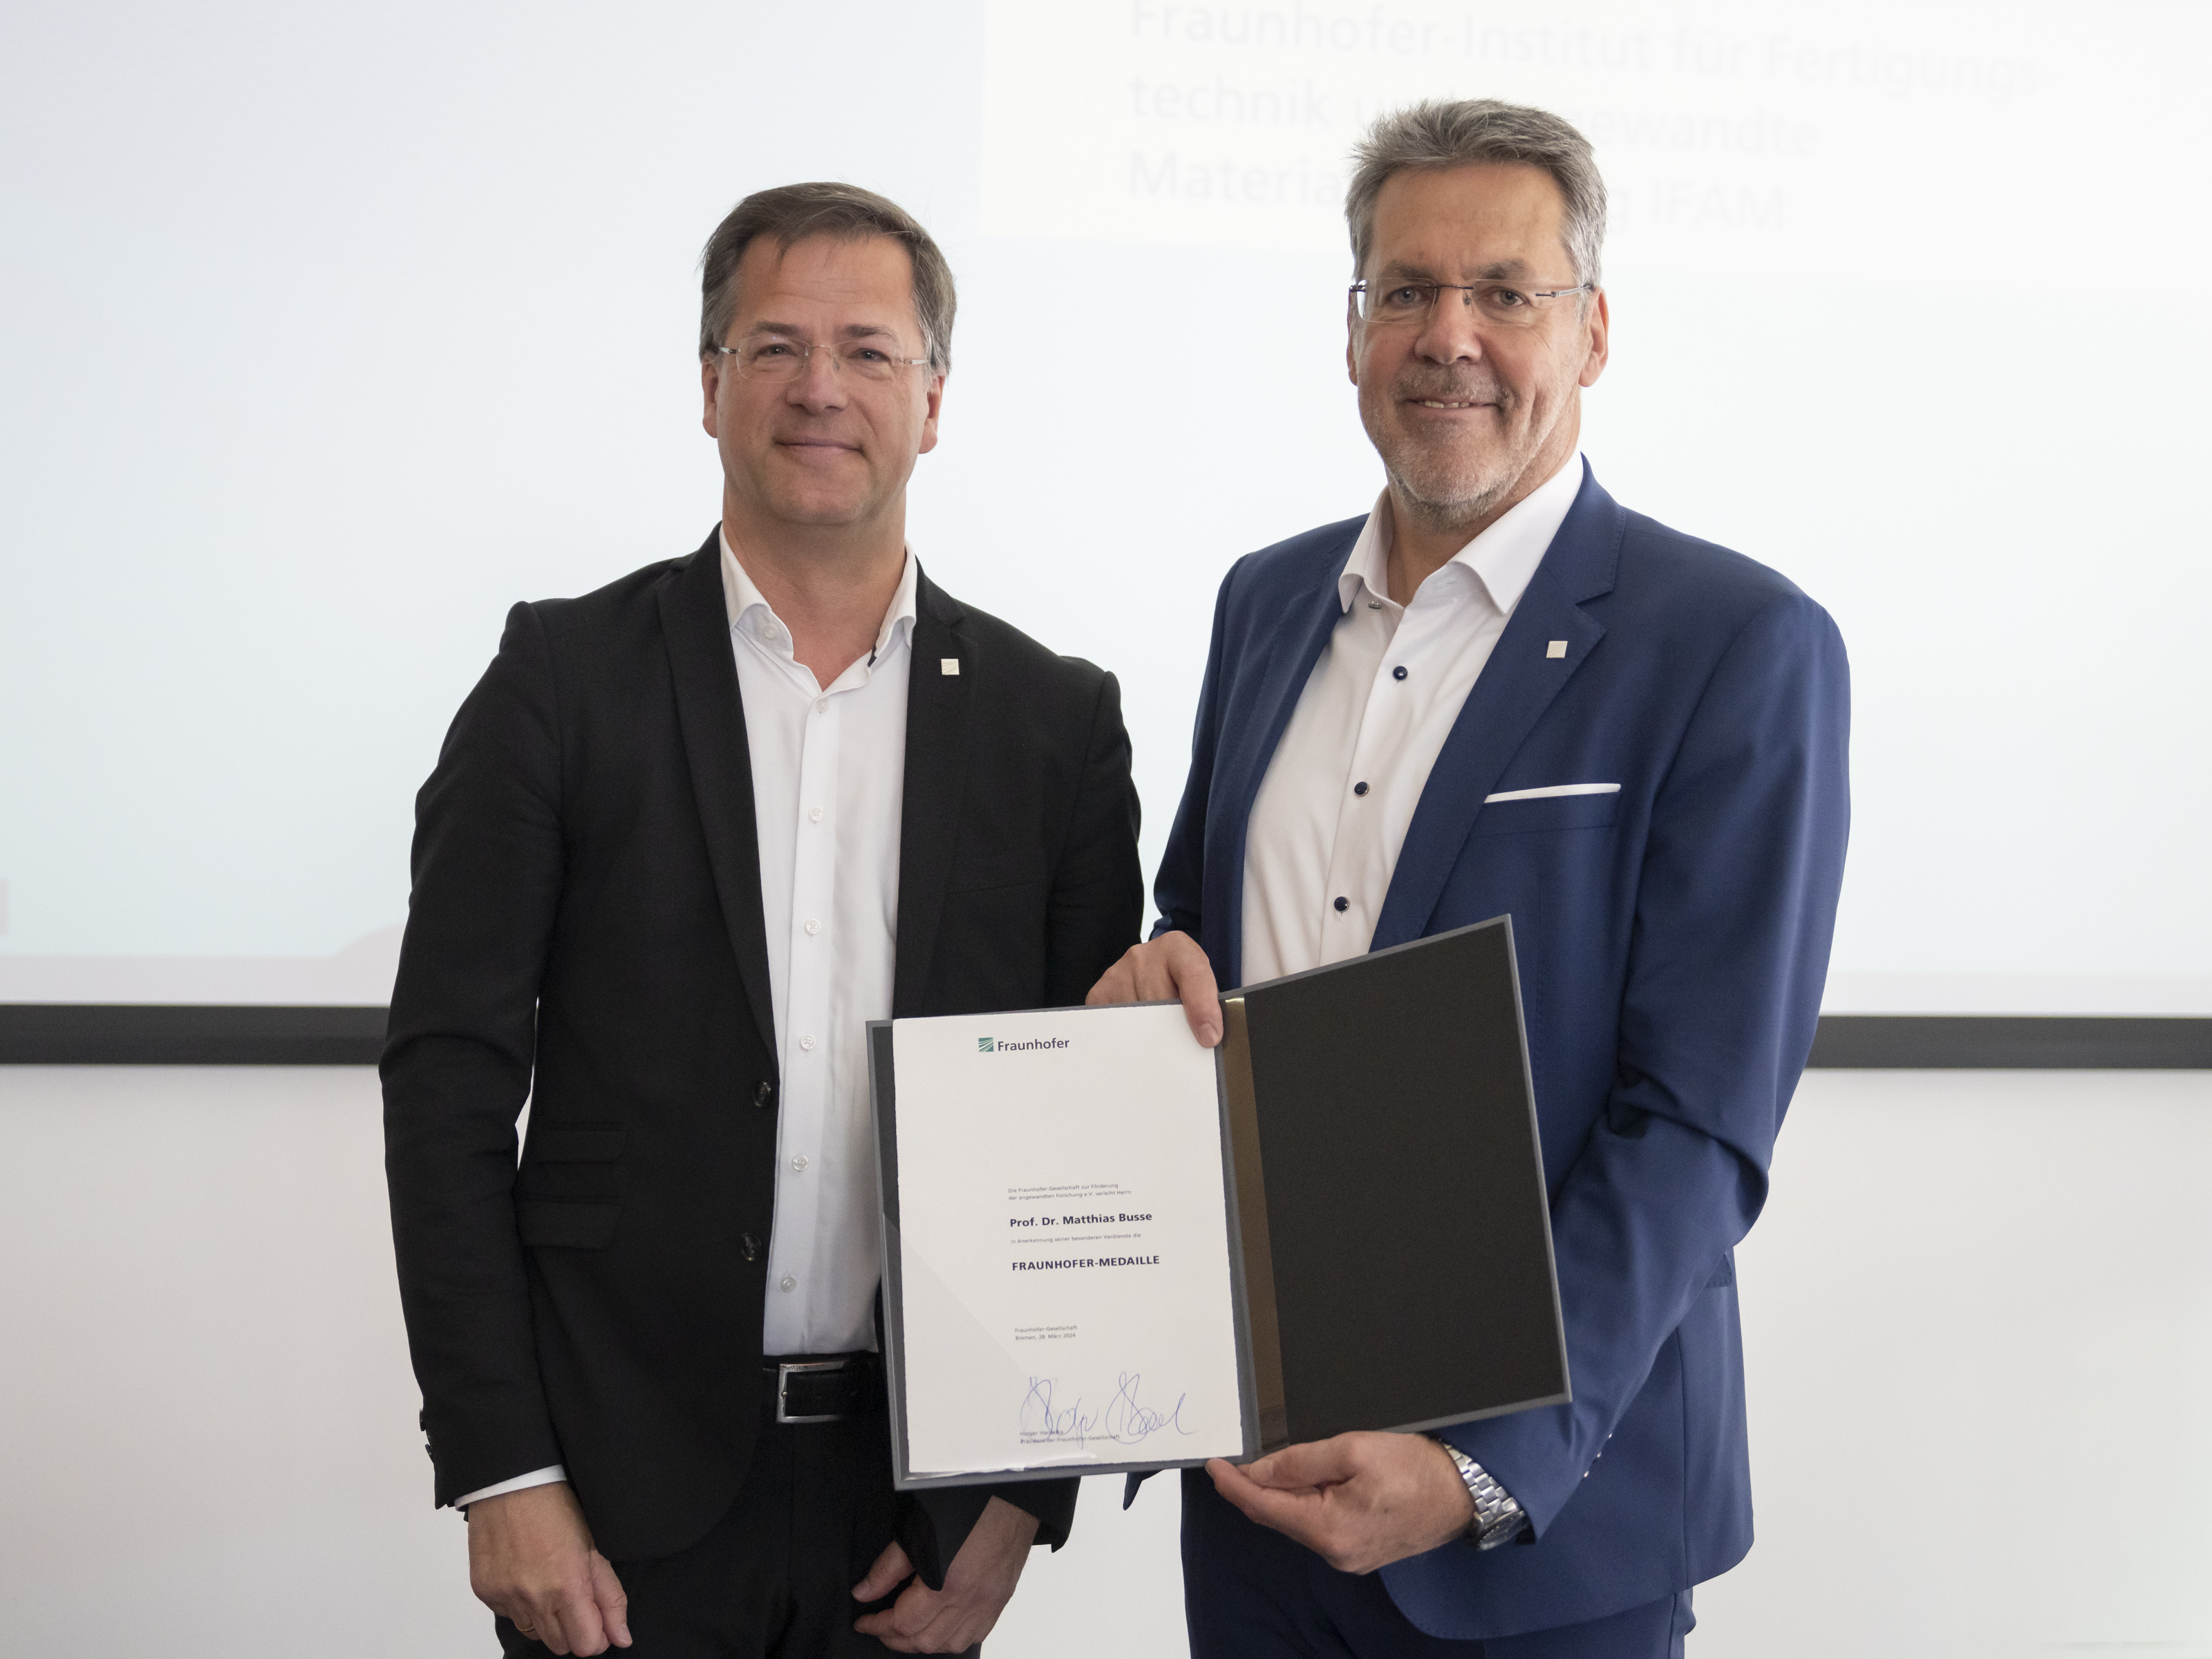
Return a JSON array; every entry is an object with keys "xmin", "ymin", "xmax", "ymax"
[{"xmin": 0, "ymin": 0, "xmax": 2212, "ymax": 1013}]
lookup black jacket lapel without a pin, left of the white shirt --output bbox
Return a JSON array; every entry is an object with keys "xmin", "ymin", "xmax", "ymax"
[{"xmin": 659, "ymin": 531, "xmax": 776, "ymax": 1055}]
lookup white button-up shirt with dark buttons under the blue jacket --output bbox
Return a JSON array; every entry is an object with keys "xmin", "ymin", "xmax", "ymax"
[{"xmin": 1243, "ymin": 456, "xmax": 1582, "ymax": 984}]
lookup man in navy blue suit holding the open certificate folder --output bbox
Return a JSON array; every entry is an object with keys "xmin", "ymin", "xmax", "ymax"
[{"xmin": 1091, "ymin": 100, "xmax": 1849, "ymax": 1659}]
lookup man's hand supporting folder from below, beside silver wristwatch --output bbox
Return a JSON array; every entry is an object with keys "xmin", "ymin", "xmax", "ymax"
[{"xmin": 1206, "ymin": 1434, "xmax": 1475, "ymax": 1573}]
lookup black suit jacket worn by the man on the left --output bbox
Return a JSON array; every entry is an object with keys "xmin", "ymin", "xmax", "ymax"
[{"xmin": 383, "ymin": 535, "xmax": 1143, "ymax": 1584}]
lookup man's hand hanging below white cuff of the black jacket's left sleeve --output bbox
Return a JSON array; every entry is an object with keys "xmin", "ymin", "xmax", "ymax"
[{"xmin": 469, "ymin": 1480, "xmax": 630, "ymax": 1655}]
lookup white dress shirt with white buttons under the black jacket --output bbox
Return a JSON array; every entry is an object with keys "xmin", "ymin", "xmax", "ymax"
[{"xmin": 453, "ymin": 538, "xmax": 916, "ymax": 1508}]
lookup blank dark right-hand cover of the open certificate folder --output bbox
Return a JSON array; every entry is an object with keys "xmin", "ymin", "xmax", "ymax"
[{"xmin": 1221, "ymin": 916, "xmax": 1571, "ymax": 1451}]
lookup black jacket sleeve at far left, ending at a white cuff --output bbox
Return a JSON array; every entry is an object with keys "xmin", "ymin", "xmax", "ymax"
[{"xmin": 380, "ymin": 604, "xmax": 562, "ymax": 1504}]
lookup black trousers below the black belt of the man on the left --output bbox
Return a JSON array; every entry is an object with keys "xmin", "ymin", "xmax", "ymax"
[{"xmin": 509, "ymin": 1389, "xmax": 982, "ymax": 1659}]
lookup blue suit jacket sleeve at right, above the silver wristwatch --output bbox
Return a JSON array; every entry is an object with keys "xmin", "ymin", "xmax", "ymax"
[{"xmin": 1445, "ymin": 595, "xmax": 1849, "ymax": 1535}]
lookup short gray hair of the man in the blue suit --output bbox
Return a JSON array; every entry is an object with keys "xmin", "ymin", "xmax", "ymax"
[{"xmin": 1345, "ymin": 97, "xmax": 1606, "ymax": 288}]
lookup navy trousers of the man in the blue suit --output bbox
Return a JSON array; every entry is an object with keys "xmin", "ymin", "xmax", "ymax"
[{"xmin": 1183, "ymin": 1469, "xmax": 1696, "ymax": 1659}]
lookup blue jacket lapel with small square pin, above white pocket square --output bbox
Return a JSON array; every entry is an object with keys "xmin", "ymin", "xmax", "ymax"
[{"xmin": 1371, "ymin": 469, "xmax": 1628, "ymax": 951}]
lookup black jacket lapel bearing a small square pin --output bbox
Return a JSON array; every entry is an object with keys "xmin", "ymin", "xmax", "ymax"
[{"xmin": 892, "ymin": 571, "xmax": 977, "ymax": 1018}]
